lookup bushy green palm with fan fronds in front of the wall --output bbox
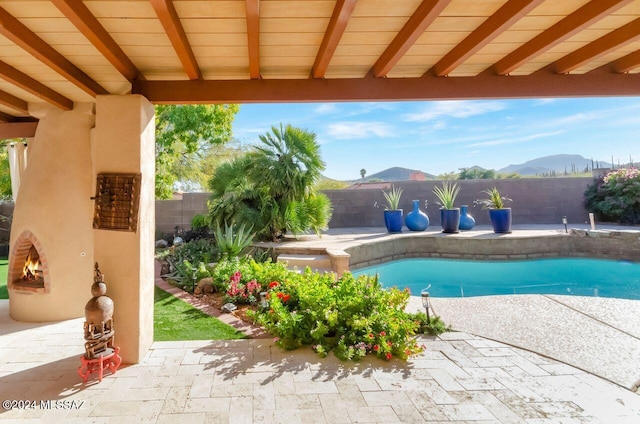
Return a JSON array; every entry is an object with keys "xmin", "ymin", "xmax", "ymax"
[{"xmin": 209, "ymin": 125, "xmax": 331, "ymax": 240}]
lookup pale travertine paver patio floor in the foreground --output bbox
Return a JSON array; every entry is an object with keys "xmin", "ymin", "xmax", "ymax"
[{"xmin": 0, "ymin": 300, "xmax": 640, "ymax": 424}]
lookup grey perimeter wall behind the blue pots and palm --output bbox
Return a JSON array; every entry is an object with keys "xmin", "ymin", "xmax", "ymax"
[{"xmin": 156, "ymin": 178, "xmax": 593, "ymax": 232}]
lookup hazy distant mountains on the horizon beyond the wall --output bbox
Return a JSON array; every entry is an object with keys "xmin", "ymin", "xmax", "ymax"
[{"xmin": 356, "ymin": 154, "xmax": 618, "ymax": 181}]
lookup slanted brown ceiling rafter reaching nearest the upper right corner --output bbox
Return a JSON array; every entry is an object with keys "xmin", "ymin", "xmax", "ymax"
[{"xmin": 485, "ymin": 0, "xmax": 633, "ymax": 75}]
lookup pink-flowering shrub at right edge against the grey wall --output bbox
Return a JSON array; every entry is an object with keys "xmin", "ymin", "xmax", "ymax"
[{"xmin": 585, "ymin": 168, "xmax": 640, "ymax": 224}]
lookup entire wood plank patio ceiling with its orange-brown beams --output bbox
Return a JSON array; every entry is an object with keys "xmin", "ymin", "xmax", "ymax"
[{"xmin": 0, "ymin": 0, "xmax": 640, "ymax": 122}]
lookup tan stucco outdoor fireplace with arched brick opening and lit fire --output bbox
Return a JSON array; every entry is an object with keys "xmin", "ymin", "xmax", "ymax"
[{"xmin": 7, "ymin": 103, "xmax": 95, "ymax": 322}]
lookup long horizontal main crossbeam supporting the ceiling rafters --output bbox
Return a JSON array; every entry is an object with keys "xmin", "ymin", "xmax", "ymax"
[{"xmin": 132, "ymin": 72, "xmax": 640, "ymax": 104}]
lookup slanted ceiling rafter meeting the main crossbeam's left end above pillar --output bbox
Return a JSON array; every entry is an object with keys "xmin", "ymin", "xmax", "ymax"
[{"xmin": 51, "ymin": 0, "xmax": 142, "ymax": 81}]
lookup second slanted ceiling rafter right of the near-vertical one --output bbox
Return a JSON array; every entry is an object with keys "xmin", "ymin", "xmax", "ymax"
[{"xmin": 371, "ymin": 0, "xmax": 451, "ymax": 77}]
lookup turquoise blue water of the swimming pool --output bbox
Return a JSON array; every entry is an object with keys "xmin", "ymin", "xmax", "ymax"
[{"xmin": 353, "ymin": 259, "xmax": 640, "ymax": 300}]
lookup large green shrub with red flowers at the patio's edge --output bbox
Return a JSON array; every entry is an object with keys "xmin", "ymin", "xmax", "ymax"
[{"xmin": 249, "ymin": 269, "xmax": 423, "ymax": 360}]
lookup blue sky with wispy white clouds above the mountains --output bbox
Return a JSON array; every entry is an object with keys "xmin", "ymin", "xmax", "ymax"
[{"xmin": 234, "ymin": 97, "xmax": 640, "ymax": 180}]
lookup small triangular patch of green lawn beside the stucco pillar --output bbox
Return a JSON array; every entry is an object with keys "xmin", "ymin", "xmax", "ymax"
[{"xmin": 153, "ymin": 287, "xmax": 246, "ymax": 341}]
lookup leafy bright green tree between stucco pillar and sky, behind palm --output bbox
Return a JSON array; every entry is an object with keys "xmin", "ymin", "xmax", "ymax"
[{"xmin": 156, "ymin": 105, "xmax": 239, "ymax": 199}]
